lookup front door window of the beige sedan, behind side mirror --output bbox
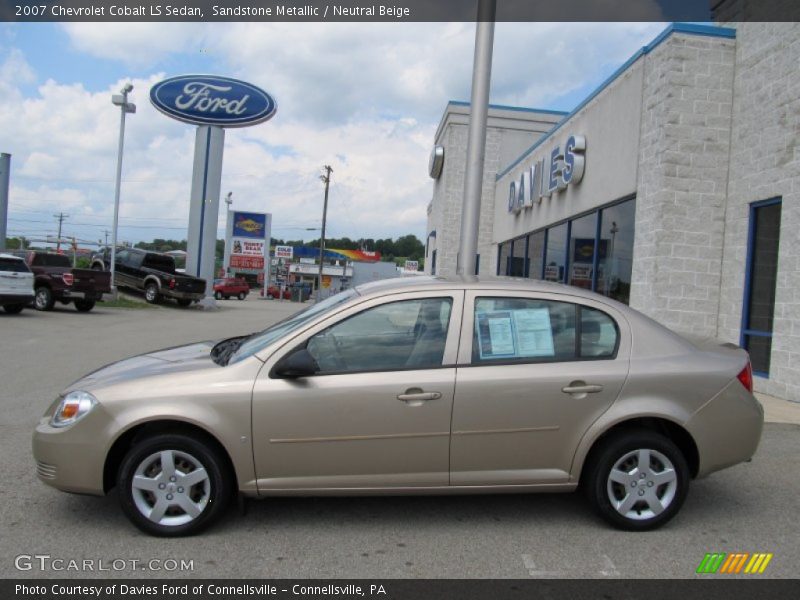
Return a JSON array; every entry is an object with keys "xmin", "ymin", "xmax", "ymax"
[{"xmin": 307, "ymin": 298, "xmax": 453, "ymax": 374}]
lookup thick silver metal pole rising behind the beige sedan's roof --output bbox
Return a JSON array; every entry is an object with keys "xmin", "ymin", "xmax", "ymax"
[{"xmin": 456, "ymin": 0, "xmax": 497, "ymax": 276}]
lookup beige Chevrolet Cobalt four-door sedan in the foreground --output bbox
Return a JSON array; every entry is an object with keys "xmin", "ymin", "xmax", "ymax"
[{"xmin": 33, "ymin": 277, "xmax": 763, "ymax": 535}]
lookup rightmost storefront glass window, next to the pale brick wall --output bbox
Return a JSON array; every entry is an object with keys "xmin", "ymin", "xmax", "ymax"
[{"xmin": 596, "ymin": 200, "xmax": 636, "ymax": 304}]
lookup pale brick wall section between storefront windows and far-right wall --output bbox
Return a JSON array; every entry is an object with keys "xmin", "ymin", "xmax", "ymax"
[{"xmin": 631, "ymin": 34, "xmax": 735, "ymax": 336}]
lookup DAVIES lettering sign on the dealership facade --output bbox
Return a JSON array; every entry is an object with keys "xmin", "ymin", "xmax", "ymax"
[{"xmin": 508, "ymin": 135, "xmax": 586, "ymax": 213}]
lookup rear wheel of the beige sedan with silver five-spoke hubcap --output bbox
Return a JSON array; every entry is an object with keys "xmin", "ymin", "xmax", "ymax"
[{"xmin": 585, "ymin": 430, "xmax": 690, "ymax": 531}]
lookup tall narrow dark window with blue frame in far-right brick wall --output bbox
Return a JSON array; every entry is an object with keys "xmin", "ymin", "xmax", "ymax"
[{"xmin": 739, "ymin": 198, "xmax": 781, "ymax": 377}]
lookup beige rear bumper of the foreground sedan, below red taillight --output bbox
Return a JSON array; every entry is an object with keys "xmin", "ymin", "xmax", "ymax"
[{"xmin": 686, "ymin": 379, "xmax": 764, "ymax": 477}]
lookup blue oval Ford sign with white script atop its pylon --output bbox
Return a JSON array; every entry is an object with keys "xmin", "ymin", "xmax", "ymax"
[{"xmin": 150, "ymin": 75, "xmax": 278, "ymax": 127}]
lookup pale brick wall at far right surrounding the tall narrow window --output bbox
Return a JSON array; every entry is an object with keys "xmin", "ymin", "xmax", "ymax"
[{"xmin": 718, "ymin": 23, "xmax": 800, "ymax": 401}]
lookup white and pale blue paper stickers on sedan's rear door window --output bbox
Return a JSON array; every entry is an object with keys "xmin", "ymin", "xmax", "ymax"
[{"xmin": 475, "ymin": 308, "xmax": 555, "ymax": 360}]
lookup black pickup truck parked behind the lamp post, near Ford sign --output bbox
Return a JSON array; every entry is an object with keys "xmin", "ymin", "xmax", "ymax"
[{"xmin": 92, "ymin": 248, "xmax": 206, "ymax": 306}]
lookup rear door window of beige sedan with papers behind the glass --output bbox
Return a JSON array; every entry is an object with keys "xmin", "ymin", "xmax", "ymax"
[{"xmin": 472, "ymin": 298, "xmax": 577, "ymax": 364}]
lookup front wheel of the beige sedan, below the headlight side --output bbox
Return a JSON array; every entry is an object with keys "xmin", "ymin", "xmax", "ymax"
[{"xmin": 117, "ymin": 434, "xmax": 232, "ymax": 537}]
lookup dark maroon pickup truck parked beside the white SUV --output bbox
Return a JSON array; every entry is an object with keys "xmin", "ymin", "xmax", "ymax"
[{"xmin": 13, "ymin": 250, "xmax": 111, "ymax": 312}]
